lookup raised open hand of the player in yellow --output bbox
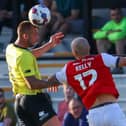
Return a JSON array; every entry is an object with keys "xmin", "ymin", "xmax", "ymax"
[{"xmin": 49, "ymin": 32, "xmax": 64, "ymax": 47}]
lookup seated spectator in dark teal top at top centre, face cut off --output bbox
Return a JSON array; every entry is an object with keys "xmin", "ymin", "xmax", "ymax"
[{"xmin": 52, "ymin": 0, "xmax": 82, "ymax": 33}]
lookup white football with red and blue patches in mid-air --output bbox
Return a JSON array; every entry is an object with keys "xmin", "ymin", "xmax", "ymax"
[{"xmin": 28, "ymin": 4, "xmax": 51, "ymax": 26}]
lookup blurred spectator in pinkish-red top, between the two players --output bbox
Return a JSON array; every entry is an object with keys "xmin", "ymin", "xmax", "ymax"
[{"xmin": 57, "ymin": 84, "xmax": 75, "ymax": 122}]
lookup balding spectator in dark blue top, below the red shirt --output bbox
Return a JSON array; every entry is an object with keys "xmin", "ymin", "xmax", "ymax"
[{"xmin": 63, "ymin": 98, "xmax": 88, "ymax": 126}]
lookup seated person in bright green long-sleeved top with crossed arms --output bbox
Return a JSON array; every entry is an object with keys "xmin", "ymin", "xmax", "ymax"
[{"xmin": 94, "ymin": 8, "xmax": 126, "ymax": 55}]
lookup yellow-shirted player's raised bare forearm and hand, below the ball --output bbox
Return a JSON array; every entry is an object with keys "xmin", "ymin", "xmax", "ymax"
[{"xmin": 32, "ymin": 32, "xmax": 64, "ymax": 58}]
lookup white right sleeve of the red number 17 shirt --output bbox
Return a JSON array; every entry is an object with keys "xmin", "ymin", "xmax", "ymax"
[{"xmin": 101, "ymin": 53, "xmax": 119, "ymax": 67}]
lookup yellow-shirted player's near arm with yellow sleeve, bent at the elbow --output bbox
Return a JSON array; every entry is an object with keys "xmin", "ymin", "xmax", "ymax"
[{"xmin": 18, "ymin": 53, "xmax": 61, "ymax": 89}]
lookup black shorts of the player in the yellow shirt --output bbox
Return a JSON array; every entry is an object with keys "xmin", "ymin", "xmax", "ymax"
[{"xmin": 15, "ymin": 93, "xmax": 56, "ymax": 126}]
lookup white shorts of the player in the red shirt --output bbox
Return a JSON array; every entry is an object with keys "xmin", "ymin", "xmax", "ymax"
[{"xmin": 87, "ymin": 103, "xmax": 126, "ymax": 126}]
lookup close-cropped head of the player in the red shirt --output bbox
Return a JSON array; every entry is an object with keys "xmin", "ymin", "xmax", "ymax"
[{"xmin": 71, "ymin": 37, "xmax": 90, "ymax": 59}]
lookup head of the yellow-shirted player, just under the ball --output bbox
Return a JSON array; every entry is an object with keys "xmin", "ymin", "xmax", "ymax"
[{"xmin": 17, "ymin": 21, "xmax": 39, "ymax": 47}]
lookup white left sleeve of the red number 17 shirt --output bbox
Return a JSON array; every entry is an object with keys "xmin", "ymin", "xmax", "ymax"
[{"xmin": 56, "ymin": 65, "xmax": 67, "ymax": 83}]
